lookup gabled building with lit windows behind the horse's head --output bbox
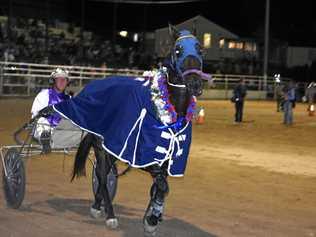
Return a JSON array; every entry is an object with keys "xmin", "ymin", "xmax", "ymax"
[{"xmin": 155, "ymin": 15, "xmax": 259, "ymax": 74}]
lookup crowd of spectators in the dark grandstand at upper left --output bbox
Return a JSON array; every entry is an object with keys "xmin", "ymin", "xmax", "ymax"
[{"xmin": 0, "ymin": 18, "xmax": 155, "ymax": 68}]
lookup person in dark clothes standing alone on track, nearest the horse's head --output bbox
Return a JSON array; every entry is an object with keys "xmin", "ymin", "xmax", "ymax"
[{"xmin": 232, "ymin": 79, "xmax": 247, "ymax": 123}]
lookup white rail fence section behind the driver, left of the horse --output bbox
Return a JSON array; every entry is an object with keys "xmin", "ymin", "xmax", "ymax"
[{"xmin": 0, "ymin": 62, "xmax": 143, "ymax": 96}]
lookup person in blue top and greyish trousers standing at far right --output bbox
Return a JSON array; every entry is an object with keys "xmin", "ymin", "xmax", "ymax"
[{"xmin": 283, "ymin": 81, "xmax": 295, "ymax": 125}]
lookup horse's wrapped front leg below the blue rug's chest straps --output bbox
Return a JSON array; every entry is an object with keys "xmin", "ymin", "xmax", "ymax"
[{"xmin": 143, "ymin": 165, "xmax": 169, "ymax": 236}]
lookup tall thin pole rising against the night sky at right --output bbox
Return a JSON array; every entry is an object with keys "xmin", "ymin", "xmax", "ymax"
[{"xmin": 263, "ymin": 0, "xmax": 270, "ymax": 90}]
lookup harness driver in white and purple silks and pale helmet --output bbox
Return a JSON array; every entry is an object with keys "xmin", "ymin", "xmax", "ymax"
[{"xmin": 31, "ymin": 68, "xmax": 70, "ymax": 153}]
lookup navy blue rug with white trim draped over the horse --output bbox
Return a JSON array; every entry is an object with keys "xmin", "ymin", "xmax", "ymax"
[{"xmin": 54, "ymin": 76, "xmax": 192, "ymax": 176}]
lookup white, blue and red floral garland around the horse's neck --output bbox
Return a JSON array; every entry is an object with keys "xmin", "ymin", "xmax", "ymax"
[{"xmin": 149, "ymin": 71, "xmax": 196, "ymax": 124}]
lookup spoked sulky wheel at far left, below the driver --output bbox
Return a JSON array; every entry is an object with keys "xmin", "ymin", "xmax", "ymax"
[{"xmin": 2, "ymin": 148, "xmax": 25, "ymax": 209}]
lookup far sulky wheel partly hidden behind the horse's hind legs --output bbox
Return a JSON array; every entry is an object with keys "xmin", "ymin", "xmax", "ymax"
[{"xmin": 92, "ymin": 164, "xmax": 117, "ymax": 201}]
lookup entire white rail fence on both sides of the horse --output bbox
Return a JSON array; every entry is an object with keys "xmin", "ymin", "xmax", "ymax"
[{"xmin": 0, "ymin": 62, "xmax": 285, "ymax": 98}]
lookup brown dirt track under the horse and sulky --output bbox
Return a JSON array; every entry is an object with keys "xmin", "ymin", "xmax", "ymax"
[{"xmin": 0, "ymin": 99, "xmax": 316, "ymax": 237}]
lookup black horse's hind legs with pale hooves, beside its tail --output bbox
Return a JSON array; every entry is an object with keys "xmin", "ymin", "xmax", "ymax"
[{"xmin": 91, "ymin": 140, "xmax": 118, "ymax": 228}]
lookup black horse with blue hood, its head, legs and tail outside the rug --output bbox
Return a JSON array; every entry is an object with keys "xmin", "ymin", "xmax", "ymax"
[{"xmin": 64, "ymin": 25, "xmax": 207, "ymax": 235}]
